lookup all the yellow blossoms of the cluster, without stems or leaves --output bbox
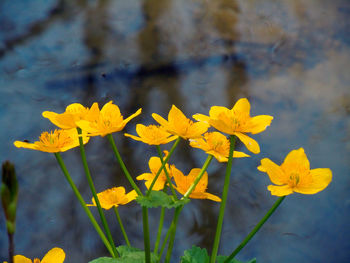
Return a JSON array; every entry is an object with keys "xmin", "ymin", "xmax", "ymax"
[{"xmin": 14, "ymin": 98, "xmax": 332, "ymax": 263}]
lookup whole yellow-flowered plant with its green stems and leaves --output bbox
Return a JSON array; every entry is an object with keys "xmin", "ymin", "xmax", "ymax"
[{"xmin": 6, "ymin": 98, "xmax": 332, "ymax": 263}]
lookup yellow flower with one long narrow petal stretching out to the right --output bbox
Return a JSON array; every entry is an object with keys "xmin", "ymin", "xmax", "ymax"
[{"xmin": 77, "ymin": 101, "xmax": 141, "ymax": 137}]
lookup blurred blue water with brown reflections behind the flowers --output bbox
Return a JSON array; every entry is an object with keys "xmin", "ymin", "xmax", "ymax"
[{"xmin": 0, "ymin": 0, "xmax": 350, "ymax": 263}]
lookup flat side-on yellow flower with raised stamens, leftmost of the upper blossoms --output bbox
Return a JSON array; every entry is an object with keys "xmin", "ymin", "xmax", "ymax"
[{"xmin": 14, "ymin": 129, "xmax": 89, "ymax": 153}]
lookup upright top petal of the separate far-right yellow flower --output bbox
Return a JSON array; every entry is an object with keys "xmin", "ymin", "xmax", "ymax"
[{"xmin": 281, "ymin": 148, "xmax": 310, "ymax": 173}]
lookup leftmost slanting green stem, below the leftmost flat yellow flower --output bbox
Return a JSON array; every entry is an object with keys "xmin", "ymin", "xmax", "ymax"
[{"xmin": 55, "ymin": 153, "xmax": 114, "ymax": 256}]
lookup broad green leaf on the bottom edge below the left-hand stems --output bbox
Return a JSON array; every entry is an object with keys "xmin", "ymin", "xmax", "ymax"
[{"xmin": 89, "ymin": 246, "xmax": 158, "ymax": 263}]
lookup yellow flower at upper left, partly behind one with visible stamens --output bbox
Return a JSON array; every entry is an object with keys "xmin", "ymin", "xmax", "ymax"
[{"xmin": 42, "ymin": 103, "xmax": 89, "ymax": 129}]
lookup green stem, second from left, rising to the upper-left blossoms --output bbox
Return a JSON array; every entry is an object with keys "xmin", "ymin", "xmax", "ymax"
[{"xmin": 77, "ymin": 128, "xmax": 119, "ymax": 257}]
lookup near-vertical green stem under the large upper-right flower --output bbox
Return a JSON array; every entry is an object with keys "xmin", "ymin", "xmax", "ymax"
[{"xmin": 210, "ymin": 135, "xmax": 236, "ymax": 263}]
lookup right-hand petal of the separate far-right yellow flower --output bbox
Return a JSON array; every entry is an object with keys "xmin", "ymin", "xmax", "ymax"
[{"xmin": 294, "ymin": 168, "xmax": 332, "ymax": 194}]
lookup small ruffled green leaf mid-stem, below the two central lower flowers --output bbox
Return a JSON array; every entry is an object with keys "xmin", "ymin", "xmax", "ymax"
[{"xmin": 136, "ymin": 191, "xmax": 190, "ymax": 208}]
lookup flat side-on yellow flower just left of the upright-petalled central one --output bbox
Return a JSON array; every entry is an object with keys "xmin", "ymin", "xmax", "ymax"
[{"xmin": 124, "ymin": 124, "xmax": 178, "ymax": 145}]
